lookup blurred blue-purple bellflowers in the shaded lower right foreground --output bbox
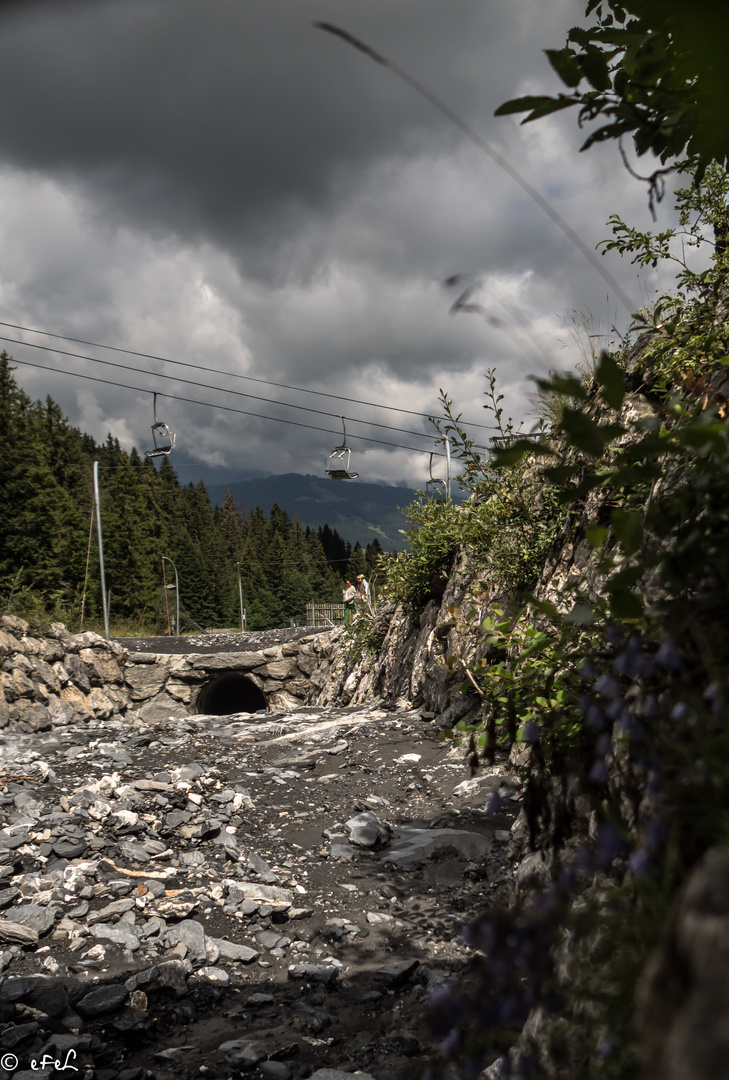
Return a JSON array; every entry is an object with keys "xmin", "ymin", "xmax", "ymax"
[{"xmin": 428, "ymin": 626, "xmax": 729, "ymax": 1080}]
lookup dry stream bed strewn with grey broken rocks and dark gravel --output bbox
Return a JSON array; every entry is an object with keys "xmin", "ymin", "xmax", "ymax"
[{"xmin": 0, "ymin": 620, "xmax": 521, "ymax": 1080}]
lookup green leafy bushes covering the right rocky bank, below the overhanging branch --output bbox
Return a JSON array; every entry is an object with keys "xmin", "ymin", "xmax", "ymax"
[{"xmin": 427, "ymin": 204, "xmax": 729, "ymax": 1080}]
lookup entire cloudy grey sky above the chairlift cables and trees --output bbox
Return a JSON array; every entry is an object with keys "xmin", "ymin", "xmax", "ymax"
[{"xmin": 0, "ymin": 0, "xmax": 682, "ymax": 484}]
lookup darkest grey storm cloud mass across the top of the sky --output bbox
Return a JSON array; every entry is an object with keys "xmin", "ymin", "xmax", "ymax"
[{"xmin": 0, "ymin": 0, "xmax": 583, "ymax": 272}]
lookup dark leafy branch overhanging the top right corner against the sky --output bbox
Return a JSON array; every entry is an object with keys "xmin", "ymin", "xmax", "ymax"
[{"xmin": 496, "ymin": 0, "xmax": 729, "ymax": 192}]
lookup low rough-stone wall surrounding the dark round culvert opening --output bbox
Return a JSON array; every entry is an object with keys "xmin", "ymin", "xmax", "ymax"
[{"xmin": 0, "ymin": 616, "xmax": 328, "ymax": 731}]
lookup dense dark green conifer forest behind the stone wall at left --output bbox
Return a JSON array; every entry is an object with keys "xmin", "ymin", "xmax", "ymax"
[{"xmin": 0, "ymin": 352, "xmax": 381, "ymax": 633}]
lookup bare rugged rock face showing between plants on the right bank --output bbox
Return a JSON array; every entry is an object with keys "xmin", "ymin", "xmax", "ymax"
[{"xmin": 310, "ymin": 395, "xmax": 729, "ymax": 1080}]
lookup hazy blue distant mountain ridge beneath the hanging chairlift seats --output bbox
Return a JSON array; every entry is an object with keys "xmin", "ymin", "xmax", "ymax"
[{"xmin": 207, "ymin": 473, "xmax": 415, "ymax": 551}]
